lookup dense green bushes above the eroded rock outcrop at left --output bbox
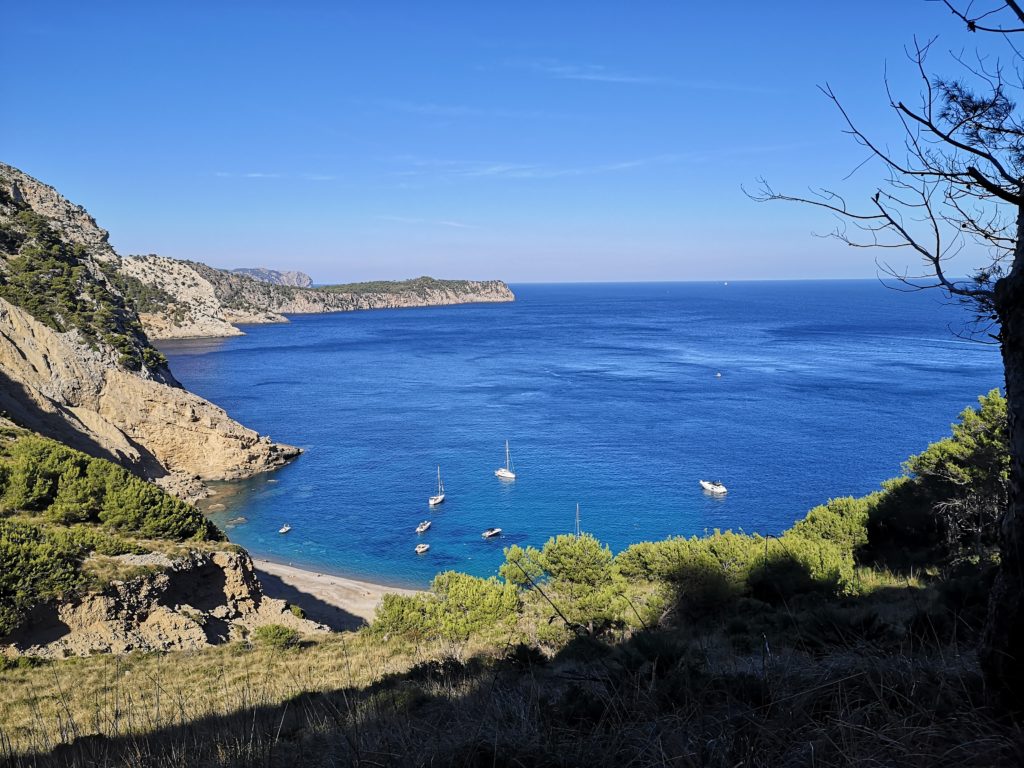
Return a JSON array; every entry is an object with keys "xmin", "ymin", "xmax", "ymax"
[{"xmin": 0, "ymin": 429, "xmax": 223, "ymax": 637}]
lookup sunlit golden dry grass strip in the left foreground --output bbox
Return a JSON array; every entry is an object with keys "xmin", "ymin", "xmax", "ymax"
[{"xmin": 0, "ymin": 634, "xmax": 432, "ymax": 759}]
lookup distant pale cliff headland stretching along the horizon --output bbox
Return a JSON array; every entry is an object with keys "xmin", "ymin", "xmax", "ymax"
[{"xmin": 118, "ymin": 262, "xmax": 515, "ymax": 339}]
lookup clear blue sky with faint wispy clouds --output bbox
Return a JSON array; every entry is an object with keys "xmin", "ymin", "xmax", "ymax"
[{"xmin": 0, "ymin": 0, "xmax": 986, "ymax": 283}]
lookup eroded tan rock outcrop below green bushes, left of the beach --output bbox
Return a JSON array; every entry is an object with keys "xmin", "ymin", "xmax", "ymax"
[{"xmin": 5, "ymin": 550, "xmax": 328, "ymax": 658}]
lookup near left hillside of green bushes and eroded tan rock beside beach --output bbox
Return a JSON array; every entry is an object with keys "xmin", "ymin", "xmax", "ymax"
[{"xmin": 0, "ymin": 419, "xmax": 322, "ymax": 658}]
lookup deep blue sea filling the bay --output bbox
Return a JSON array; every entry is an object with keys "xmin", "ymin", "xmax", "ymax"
[{"xmin": 161, "ymin": 281, "xmax": 1002, "ymax": 587}]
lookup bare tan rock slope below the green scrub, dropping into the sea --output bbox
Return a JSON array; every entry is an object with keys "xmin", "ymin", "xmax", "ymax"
[{"xmin": 0, "ymin": 299, "xmax": 298, "ymax": 480}]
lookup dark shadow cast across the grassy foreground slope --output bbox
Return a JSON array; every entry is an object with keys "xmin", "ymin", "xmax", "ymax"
[{"xmin": 12, "ymin": 588, "xmax": 1024, "ymax": 768}]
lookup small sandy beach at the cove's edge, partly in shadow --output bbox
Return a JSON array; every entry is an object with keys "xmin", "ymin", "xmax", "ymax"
[{"xmin": 253, "ymin": 558, "xmax": 416, "ymax": 631}]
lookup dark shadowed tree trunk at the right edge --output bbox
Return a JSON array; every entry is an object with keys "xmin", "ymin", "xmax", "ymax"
[{"xmin": 981, "ymin": 211, "xmax": 1024, "ymax": 713}]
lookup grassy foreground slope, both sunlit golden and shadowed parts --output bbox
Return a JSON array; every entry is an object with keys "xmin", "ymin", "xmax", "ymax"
[{"xmin": 0, "ymin": 631, "xmax": 1024, "ymax": 768}]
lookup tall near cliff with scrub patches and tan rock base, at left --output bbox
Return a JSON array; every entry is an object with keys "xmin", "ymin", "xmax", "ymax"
[{"xmin": 0, "ymin": 164, "xmax": 298, "ymax": 495}]
